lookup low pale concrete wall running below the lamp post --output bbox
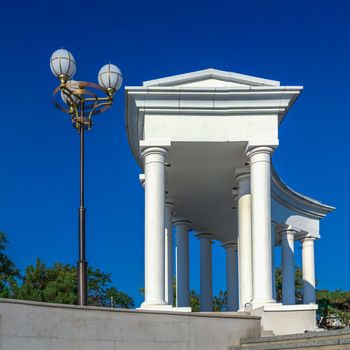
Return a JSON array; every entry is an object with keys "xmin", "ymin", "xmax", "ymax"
[{"xmin": 0, "ymin": 299, "xmax": 261, "ymax": 350}]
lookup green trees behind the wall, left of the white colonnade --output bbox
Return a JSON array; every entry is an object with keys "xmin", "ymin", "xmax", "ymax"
[{"xmin": 0, "ymin": 234, "xmax": 135, "ymax": 308}]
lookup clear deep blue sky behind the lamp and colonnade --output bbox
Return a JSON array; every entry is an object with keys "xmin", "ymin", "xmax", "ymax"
[{"xmin": 0, "ymin": 0, "xmax": 350, "ymax": 302}]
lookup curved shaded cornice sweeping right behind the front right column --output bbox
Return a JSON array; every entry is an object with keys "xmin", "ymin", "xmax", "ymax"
[{"xmin": 271, "ymin": 166, "xmax": 335, "ymax": 219}]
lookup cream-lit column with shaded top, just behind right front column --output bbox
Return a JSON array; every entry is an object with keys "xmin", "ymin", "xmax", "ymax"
[{"xmin": 236, "ymin": 169, "xmax": 253, "ymax": 311}]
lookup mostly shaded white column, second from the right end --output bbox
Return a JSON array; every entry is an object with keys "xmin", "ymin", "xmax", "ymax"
[{"xmin": 281, "ymin": 229, "xmax": 295, "ymax": 305}]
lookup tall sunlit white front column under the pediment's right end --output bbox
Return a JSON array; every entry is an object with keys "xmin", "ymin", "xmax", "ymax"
[{"xmin": 248, "ymin": 147, "xmax": 275, "ymax": 307}]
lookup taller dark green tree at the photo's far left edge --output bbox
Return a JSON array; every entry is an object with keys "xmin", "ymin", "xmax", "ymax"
[{"xmin": 0, "ymin": 232, "xmax": 21, "ymax": 298}]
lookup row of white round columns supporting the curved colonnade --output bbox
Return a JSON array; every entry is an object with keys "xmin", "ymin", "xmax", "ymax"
[{"xmin": 141, "ymin": 147, "xmax": 315, "ymax": 312}]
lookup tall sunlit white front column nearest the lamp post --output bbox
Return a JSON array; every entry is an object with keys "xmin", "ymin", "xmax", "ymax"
[{"xmin": 141, "ymin": 147, "xmax": 167, "ymax": 308}]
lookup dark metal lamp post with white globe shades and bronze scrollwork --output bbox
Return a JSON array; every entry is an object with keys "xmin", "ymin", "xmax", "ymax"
[{"xmin": 50, "ymin": 49, "xmax": 123, "ymax": 305}]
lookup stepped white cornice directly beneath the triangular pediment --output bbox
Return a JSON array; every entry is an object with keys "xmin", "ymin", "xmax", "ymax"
[{"xmin": 125, "ymin": 85, "xmax": 302, "ymax": 164}]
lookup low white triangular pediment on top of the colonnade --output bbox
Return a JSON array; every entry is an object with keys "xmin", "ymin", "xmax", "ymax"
[{"xmin": 143, "ymin": 68, "xmax": 280, "ymax": 88}]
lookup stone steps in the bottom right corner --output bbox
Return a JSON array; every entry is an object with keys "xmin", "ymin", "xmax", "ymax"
[{"xmin": 230, "ymin": 329, "xmax": 350, "ymax": 350}]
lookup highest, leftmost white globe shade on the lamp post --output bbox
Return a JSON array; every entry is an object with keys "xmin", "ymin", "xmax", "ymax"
[{"xmin": 50, "ymin": 49, "xmax": 77, "ymax": 80}]
